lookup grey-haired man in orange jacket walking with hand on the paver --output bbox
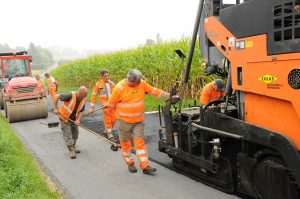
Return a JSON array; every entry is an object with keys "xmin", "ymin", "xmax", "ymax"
[{"xmin": 108, "ymin": 69, "xmax": 179, "ymax": 174}]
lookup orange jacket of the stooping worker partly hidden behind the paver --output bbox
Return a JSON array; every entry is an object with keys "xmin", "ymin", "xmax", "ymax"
[{"xmin": 200, "ymin": 81, "xmax": 225, "ymax": 106}]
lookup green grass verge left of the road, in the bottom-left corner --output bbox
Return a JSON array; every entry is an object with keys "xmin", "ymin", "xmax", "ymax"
[{"xmin": 0, "ymin": 116, "xmax": 61, "ymax": 199}]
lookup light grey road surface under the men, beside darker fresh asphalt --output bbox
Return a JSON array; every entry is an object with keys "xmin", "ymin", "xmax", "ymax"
[{"xmin": 6, "ymin": 95, "xmax": 237, "ymax": 199}]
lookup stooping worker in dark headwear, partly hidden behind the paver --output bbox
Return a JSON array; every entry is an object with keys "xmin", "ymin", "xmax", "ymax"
[{"xmin": 200, "ymin": 79, "xmax": 225, "ymax": 106}]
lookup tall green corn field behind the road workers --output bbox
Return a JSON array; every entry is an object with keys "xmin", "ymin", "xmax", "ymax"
[{"xmin": 51, "ymin": 38, "xmax": 213, "ymax": 99}]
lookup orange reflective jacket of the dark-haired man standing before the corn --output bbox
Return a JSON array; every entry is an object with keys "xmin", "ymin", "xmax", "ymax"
[{"xmin": 90, "ymin": 79, "xmax": 114, "ymax": 106}]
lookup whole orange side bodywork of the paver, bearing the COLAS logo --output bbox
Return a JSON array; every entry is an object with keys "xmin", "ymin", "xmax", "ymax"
[{"xmin": 205, "ymin": 17, "xmax": 300, "ymax": 150}]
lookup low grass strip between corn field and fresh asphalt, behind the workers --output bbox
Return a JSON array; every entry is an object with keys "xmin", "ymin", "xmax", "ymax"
[{"xmin": 57, "ymin": 87, "xmax": 199, "ymax": 112}]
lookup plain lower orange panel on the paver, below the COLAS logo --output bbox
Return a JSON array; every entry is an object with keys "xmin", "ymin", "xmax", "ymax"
[{"xmin": 245, "ymin": 93, "xmax": 300, "ymax": 150}]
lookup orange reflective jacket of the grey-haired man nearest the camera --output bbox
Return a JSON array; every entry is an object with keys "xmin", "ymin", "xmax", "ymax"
[{"xmin": 108, "ymin": 79, "xmax": 161, "ymax": 123}]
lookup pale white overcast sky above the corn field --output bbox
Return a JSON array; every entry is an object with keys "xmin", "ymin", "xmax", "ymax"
[{"xmin": 0, "ymin": 0, "xmax": 204, "ymax": 50}]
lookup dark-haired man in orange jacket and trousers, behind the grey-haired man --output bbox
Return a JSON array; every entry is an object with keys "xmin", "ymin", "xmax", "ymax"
[{"xmin": 89, "ymin": 70, "xmax": 116, "ymax": 142}]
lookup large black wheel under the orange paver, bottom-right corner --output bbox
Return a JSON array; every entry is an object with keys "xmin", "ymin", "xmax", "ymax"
[{"xmin": 251, "ymin": 156, "xmax": 299, "ymax": 199}]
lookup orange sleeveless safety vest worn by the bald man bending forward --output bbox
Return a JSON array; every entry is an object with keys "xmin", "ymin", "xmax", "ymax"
[{"xmin": 59, "ymin": 91, "xmax": 85, "ymax": 123}]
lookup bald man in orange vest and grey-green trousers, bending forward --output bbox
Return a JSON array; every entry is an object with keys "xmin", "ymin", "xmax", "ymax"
[{"xmin": 54, "ymin": 86, "xmax": 88, "ymax": 159}]
